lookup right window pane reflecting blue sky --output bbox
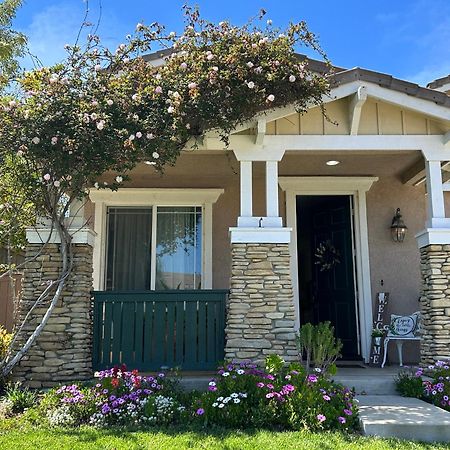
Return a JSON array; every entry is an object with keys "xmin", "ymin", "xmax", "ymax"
[{"xmin": 155, "ymin": 207, "xmax": 202, "ymax": 289}]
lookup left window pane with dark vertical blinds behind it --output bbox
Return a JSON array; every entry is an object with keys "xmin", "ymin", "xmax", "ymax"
[{"xmin": 106, "ymin": 208, "xmax": 152, "ymax": 291}]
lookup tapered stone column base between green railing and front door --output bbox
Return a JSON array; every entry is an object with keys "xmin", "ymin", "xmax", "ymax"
[{"xmin": 225, "ymin": 243, "xmax": 298, "ymax": 363}]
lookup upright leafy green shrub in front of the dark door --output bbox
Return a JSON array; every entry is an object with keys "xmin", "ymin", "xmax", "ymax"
[{"xmin": 296, "ymin": 322, "xmax": 342, "ymax": 374}]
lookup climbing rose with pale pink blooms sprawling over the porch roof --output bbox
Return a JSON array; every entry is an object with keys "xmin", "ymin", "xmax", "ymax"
[{"xmin": 0, "ymin": 7, "xmax": 328, "ymax": 213}]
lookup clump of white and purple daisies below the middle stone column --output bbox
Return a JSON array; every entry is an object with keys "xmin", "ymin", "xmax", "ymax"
[{"xmin": 197, "ymin": 363, "xmax": 356, "ymax": 430}]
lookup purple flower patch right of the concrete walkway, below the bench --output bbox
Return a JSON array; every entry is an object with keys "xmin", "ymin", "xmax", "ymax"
[{"xmin": 396, "ymin": 361, "xmax": 450, "ymax": 411}]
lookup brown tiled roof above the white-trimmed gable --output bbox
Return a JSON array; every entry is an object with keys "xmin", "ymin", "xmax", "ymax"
[{"xmin": 143, "ymin": 48, "xmax": 450, "ymax": 108}]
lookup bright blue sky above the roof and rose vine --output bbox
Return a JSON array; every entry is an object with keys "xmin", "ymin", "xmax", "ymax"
[{"xmin": 14, "ymin": 0, "xmax": 450, "ymax": 85}]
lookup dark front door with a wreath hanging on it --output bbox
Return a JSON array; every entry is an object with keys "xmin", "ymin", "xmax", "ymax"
[{"xmin": 297, "ymin": 195, "xmax": 359, "ymax": 359}]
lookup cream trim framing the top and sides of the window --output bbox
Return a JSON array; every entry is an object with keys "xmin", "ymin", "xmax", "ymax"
[{"xmin": 89, "ymin": 188, "xmax": 224, "ymax": 290}]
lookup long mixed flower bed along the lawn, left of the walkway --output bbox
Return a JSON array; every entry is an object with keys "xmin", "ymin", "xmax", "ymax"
[{"xmin": 0, "ymin": 357, "xmax": 357, "ymax": 430}]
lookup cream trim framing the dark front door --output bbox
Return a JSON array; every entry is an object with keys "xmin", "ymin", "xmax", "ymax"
[{"xmin": 278, "ymin": 177, "xmax": 378, "ymax": 362}]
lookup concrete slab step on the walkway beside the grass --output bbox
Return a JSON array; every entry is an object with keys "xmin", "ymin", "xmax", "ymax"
[{"xmin": 357, "ymin": 395, "xmax": 450, "ymax": 442}]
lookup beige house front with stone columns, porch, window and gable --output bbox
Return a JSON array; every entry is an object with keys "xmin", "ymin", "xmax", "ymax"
[{"xmin": 12, "ymin": 54, "xmax": 450, "ymax": 386}]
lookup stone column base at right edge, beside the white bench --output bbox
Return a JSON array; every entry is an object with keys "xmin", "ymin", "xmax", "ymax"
[{"xmin": 420, "ymin": 244, "xmax": 450, "ymax": 365}]
